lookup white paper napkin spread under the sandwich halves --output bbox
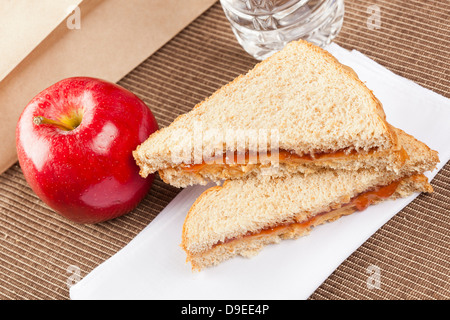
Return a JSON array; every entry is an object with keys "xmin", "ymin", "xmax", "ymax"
[{"xmin": 70, "ymin": 44, "xmax": 450, "ymax": 300}]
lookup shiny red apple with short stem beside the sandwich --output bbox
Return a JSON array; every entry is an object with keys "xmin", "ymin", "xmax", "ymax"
[{"xmin": 16, "ymin": 77, "xmax": 158, "ymax": 223}]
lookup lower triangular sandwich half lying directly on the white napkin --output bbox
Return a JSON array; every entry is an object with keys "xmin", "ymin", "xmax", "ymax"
[{"xmin": 181, "ymin": 130, "xmax": 439, "ymax": 270}]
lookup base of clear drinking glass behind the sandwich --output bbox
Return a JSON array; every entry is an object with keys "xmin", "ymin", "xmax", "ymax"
[{"xmin": 220, "ymin": 0, "xmax": 344, "ymax": 60}]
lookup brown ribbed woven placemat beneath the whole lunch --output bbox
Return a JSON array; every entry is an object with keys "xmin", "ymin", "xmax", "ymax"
[{"xmin": 0, "ymin": 0, "xmax": 450, "ymax": 300}]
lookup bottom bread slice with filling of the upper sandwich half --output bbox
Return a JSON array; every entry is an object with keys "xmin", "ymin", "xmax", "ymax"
[{"xmin": 159, "ymin": 134, "xmax": 407, "ymax": 188}]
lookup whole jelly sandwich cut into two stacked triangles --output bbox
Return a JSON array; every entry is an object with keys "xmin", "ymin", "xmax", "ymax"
[{"xmin": 133, "ymin": 40, "xmax": 439, "ymax": 270}]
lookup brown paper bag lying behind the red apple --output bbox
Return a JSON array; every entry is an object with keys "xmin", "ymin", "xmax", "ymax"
[{"xmin": 0, "ymin": 0, "xmax": 216, "ymax": 173}]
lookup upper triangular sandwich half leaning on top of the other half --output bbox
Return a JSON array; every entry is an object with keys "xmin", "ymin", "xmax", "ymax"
[{"xmin": 133, "ymin": 40, "xmax": 403, "ymax": 187}]
